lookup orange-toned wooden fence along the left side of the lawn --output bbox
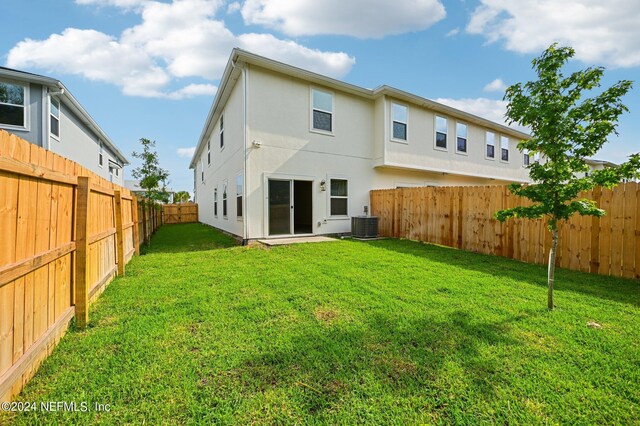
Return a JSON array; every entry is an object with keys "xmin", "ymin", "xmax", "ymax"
[{"xmin": 0, "ymin": 131, "xmax": 155, "ymax": 401}]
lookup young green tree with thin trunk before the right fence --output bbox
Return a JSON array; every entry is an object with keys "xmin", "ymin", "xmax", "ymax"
[{"xmin": 496, "ymin": 44, "xmax": 640, "ymax": 309}]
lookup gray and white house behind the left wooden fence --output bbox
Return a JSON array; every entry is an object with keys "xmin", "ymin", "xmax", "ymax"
[{"xmin": 0, "ymin": 67, "xmax": 129, "ymax": 185}]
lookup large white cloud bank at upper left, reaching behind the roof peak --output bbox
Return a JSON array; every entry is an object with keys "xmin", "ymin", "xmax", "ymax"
[{"xmin": 7, "ymin": 0, "xmax": 355, "ymax": 99}]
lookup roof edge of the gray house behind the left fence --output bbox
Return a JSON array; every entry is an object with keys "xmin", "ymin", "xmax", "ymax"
[{"xmin": 0, "ymin": 67, "xmax": 129, "ymax": 165}]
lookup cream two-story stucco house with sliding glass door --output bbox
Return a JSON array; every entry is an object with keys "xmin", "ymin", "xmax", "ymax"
[{"xmin": 190, "ymin": 49, "xmax": 533, "ymax": 240}]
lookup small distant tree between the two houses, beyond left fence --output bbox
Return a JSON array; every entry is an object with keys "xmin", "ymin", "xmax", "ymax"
[{"xmin": 131, "ymin": 138, "xmax": 169, "ymax": 203}]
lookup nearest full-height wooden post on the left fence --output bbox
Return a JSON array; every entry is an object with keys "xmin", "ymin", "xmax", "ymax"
[{"xmin": 75, "ymin": 176, "xmax": 91, "ymax": 328}]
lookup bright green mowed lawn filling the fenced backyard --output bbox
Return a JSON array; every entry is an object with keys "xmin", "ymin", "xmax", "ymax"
[{"xmin": 0, "ymin": 225, "xmax": 640, "ymax": 425}]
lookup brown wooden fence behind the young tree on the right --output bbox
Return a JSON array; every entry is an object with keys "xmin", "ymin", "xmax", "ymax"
[{"xmin": 371, "ymin": 182, "xmax": 640, "ymax": 278}]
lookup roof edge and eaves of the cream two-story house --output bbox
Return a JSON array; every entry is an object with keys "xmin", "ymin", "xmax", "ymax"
[{"xmin": 189, "ymin": 48, "xmax": 530, "ymax": 169}]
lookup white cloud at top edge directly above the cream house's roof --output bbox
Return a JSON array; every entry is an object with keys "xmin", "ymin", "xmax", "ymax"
[{"xmin": 242, "ymin": 0, "xmax": 446, "ymax": 38}]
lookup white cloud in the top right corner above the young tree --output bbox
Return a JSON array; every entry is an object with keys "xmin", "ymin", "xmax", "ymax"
[{"xmin": 466, "ymin": 0, "xmax": 640, "ymax": 67}]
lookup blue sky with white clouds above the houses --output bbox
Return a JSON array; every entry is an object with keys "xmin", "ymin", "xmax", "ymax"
[{"xmin": 0, "ymin": 0, "xmax": 640, "ymax": 191}]
